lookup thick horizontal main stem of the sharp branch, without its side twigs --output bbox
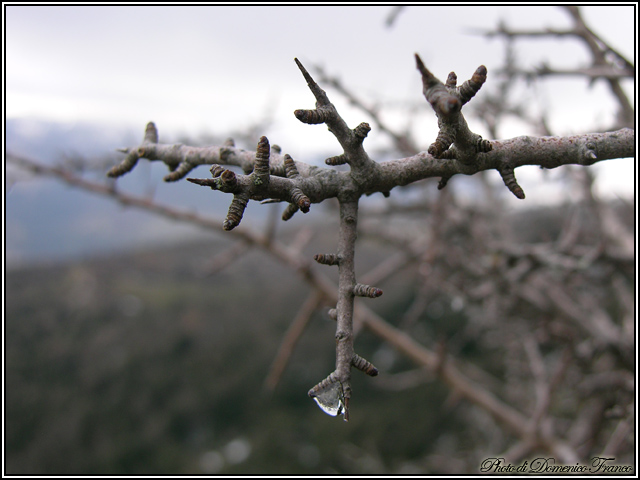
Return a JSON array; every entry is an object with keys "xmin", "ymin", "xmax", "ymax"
[{"xmin": 109, "ymin": 122, "xmax": 635, "ymax": 208}]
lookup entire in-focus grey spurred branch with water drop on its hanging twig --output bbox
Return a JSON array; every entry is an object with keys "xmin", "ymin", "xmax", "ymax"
[{"xmin": 100, "ymin": 55, "xmax": 634, "ymax": 424}]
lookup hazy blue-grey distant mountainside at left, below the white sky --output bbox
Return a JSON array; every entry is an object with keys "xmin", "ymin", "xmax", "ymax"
[{"xmin": 5, "ymin": 119, "xmax": 264, "ymax": 268}]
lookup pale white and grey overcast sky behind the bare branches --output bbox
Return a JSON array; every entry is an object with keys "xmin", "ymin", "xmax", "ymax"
[{"xmin": 5, "ymin": 5, "xmax": 636, "ymax": 197}]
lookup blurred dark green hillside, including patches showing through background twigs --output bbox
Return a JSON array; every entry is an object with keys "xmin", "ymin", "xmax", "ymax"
[{"xmin": 5, "ymin": 201, "xmax": 633, "ymax": 475}]
